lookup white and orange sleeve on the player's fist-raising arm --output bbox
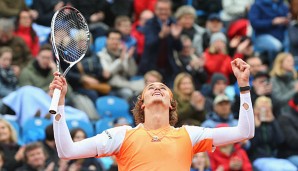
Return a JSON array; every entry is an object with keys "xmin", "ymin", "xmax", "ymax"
[{"xmin": 185, "ymin": 93, "xmax": 255, "ymax": 153}]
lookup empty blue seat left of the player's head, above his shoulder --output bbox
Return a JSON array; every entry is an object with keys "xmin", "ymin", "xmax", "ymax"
[{"xmin": 96, "ymin": 95, "xmax": 130, "ymax": 118}]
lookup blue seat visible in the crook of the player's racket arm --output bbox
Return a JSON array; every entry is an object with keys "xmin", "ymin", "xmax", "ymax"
[{"xmin": 66, "ymin": 120, "xmax": 94, "ymax": 137}]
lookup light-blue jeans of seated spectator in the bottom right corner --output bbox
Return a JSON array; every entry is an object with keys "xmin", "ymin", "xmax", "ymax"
[{"xmin": 253, "ymin": 157, "xmax": 297, "ymax": 171}]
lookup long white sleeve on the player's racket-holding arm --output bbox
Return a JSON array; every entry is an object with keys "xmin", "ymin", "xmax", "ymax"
[{"xmin": 53, "ymin": 106, "xmax": 131, "ymax": 159}]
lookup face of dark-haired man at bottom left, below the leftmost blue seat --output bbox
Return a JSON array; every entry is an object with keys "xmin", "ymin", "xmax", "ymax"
[{"xmin": 25, "ymin": 148, "xmax": 46, "ymax": 168}]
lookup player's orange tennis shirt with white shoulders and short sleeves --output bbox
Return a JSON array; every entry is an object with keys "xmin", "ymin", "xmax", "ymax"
[{"xmin": 98, "ymin": 124, "xmax": 213, "ymax": 171}]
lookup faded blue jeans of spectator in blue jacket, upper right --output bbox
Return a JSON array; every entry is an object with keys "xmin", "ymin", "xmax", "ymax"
[{"xmin": 254, "ymin": 34, "xmax": 283, "ymax": 65}]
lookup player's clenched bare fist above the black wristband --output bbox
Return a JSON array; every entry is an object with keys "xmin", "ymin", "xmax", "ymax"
[{"xmin": 231, "ymin": 58, "xmax": 250, "ymax": 87}]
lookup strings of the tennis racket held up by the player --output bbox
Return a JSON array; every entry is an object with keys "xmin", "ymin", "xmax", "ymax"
[{"xmin": 53, "ymin": 9, "xmax": 88, "ymax": 62}]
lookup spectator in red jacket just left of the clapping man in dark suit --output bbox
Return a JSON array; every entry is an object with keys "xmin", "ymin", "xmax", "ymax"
[{"xmin": 131, "ymin": 9, "xmax": 154, "ymax": 63}]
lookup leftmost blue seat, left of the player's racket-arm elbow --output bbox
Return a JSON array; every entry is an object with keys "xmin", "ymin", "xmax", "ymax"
[{"xmin": 22, "ymin": 118, "xmax": 52, "ymax": 144}]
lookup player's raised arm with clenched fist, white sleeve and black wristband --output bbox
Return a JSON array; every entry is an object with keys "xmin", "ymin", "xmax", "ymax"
[{"xmin": 212, "ymin": 58, "xmax": 255, "ymax": 146}]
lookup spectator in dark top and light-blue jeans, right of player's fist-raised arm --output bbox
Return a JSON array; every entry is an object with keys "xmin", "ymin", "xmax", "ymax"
[{"xmin": 248, "ymin": 96, "xmax": 297, "ymax": 171}]
